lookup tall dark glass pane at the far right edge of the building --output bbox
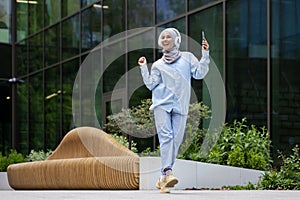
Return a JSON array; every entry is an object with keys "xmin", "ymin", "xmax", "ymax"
[{"xmin": 271, "ymin": 0, "xmax": 300, "ymax": 151}]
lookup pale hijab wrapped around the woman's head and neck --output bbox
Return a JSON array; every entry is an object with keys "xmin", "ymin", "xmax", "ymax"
[{"xmin": 158, "ymin": 28, "xmax": 181, "ymax": 64}]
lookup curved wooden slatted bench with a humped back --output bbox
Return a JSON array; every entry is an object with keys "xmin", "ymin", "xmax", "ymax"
[{"xmin": 7, "ymin": 127, "xmax": 139, "ymax": 189}]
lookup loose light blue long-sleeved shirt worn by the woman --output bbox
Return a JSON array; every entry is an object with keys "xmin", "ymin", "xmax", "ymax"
[{"xmin": 140, "ymin": 50, "xmax": 210, "ymax": 115}]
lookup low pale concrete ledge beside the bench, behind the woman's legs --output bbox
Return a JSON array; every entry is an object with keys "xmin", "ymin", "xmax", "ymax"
[{"xmin": 140, "ymin": 157, "xmax": 264, "ymax": 190}]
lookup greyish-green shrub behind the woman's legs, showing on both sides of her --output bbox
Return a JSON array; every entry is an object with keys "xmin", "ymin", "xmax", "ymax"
[{"xmin": 105, "ymin": 99, "xmax": 210, "ymax": 155}]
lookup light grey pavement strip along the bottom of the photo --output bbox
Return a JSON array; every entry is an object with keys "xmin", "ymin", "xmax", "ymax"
[{"xmin": 0, "ymin": 190, "xmax": 300, "ymax": 200}]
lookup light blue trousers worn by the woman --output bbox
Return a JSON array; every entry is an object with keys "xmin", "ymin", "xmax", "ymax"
[{"xmin": 154, "ymin": 107, "xmax": 187, "ymax": 175}]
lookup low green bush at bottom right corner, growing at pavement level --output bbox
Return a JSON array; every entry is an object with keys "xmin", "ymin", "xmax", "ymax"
[{"xmin": 258, "ymin": 145, "xmax": 300, "ymax": 190}]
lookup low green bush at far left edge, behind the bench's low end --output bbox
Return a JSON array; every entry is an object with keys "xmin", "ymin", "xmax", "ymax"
[{"xmin": 0, "ymin": 150, "xmax": 26, "ymax": 172}]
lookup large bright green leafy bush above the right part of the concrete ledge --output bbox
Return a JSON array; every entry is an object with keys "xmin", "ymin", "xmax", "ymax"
[{"xmin": 198, "ymin": 118, "xmax": 272, "ymax": 170}]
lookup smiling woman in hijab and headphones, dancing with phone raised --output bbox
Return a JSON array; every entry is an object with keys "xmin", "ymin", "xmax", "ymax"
[{"xmin": 138, "ymin": 28, "xmax": 210, "ymax": 193}]
